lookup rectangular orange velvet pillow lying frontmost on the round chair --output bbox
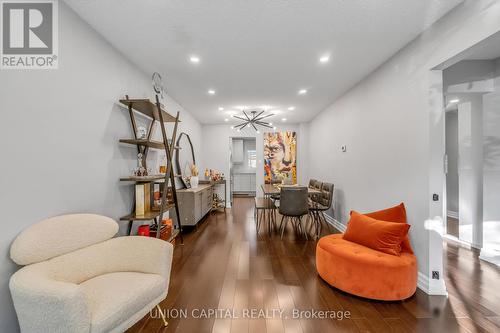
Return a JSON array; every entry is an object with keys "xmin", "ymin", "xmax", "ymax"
[{"xmin": 343, "ymin": 211, "xmax": 410, "ymax": 256}]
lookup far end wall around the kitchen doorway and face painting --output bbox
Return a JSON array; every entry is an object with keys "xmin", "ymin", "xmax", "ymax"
[{"xmin": 200, "ymin": 124, "xmax": 307, "ymax": 203}]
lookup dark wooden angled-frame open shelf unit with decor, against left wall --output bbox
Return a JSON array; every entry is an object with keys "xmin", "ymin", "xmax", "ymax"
[{"xmin": 119, "ymin": 94, "xmax": 183, "ymax": 244}]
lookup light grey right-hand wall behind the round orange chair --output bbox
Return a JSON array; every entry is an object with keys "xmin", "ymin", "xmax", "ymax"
[{"xmin": 309, "ymin": 0, "xmax": 500, "ymax": 293}]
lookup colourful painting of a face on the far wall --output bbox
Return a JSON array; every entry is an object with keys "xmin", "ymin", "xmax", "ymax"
[{"xmin": 264, "ymin": 132, "xmax": 297, "ymax": 184}]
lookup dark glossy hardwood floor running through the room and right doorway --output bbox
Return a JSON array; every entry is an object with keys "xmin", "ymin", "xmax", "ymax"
[{"xmin": 129, "ymin": 198, "xmax": 500, "ymax": 333}]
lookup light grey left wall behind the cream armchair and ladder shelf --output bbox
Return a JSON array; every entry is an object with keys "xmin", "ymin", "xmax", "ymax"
[{"xmin": 0, "ymin": 1, "xmax": 201, "ymax": 332}]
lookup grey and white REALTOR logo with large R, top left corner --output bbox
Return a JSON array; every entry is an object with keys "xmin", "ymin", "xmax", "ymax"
[{"xmin": 0, "ymin": 0, "xmax": 59, "ymax": 69}]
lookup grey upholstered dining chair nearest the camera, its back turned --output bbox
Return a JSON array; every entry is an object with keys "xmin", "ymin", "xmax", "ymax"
[{"xmin": 279, "ymin": 186, "xmax": 309, "ymax": 239}]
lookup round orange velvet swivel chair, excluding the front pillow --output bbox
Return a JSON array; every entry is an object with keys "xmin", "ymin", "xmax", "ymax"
[{"xmin": 316, "ymin": 204, "xmax": 417, "ymax": 301}]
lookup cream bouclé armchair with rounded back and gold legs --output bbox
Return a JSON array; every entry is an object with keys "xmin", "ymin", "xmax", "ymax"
[{"xmin": 9, "ymin": 214, "xmax": 173, "ymax": 333}]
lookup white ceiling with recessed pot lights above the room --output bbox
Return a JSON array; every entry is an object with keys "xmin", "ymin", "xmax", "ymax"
[{"xmin": 66, "ymin": 0, "xmax": 462, "ymax": 123}]
